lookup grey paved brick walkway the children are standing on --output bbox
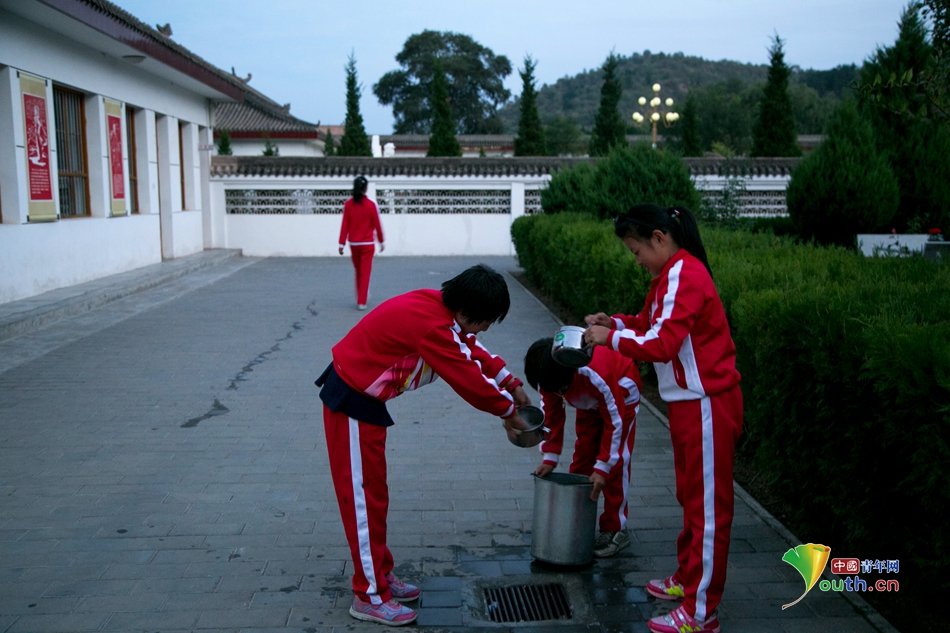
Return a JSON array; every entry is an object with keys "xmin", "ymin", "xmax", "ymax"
[{"xmin": 0, "ymin": 255, "xmax": 893, "ymax": 633}]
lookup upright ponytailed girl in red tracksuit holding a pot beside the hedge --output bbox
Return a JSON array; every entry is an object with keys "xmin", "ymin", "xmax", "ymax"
[{"xmin": 585, "ymin": 204, "xmax": 742, "ymax": 633}]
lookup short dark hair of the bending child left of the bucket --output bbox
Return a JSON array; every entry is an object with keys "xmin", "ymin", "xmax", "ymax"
[{"xmin": 442, "ymin": 264, "xmax": 511, "ymax": 323}]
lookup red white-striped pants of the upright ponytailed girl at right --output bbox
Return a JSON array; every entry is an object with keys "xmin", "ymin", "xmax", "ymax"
[{"xmin": 667, "ymin": 385, "xmax": 742, "ymax": 621}]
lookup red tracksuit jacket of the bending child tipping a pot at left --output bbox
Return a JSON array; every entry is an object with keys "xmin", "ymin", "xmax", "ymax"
[{"xmin": 333, "ymin": 289, "xmax": 521, "ymax": 417}]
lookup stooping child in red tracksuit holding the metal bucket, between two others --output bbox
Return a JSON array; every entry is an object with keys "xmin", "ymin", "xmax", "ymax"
[{"xmin": 524, "ymin": 338, "xmax": 641, "ymax": 558}]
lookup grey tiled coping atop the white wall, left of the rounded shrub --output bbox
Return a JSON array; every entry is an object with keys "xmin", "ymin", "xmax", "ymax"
[{"xmin": 211, "ymin": 156, "xmax": 591, "ymax": 178}]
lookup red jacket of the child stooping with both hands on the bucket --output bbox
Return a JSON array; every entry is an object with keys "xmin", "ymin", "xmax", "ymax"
[{"xmin": 538, "ymin": 347, "xmax": 643, "ymax": 477}]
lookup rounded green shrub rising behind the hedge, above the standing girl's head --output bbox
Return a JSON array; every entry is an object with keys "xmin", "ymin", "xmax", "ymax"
[{"xmin": 541, "ymin": 144, "xmax": 700, "ymax": 218}]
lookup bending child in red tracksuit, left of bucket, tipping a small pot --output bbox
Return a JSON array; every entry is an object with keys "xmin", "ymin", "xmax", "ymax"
[{"xmin": 317, "ymin": 265, "xmax": 530, "ymax": 626}]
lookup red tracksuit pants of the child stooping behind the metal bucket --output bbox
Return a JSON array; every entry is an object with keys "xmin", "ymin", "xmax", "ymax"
[{"xmin": 568, "ymin": 407, "xmax": 637, "ymax": 532}]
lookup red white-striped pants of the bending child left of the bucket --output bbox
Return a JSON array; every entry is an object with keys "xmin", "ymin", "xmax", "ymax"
[{"xmin": 323, "ymin": 406, "xmax": 393, "ymax": 604}]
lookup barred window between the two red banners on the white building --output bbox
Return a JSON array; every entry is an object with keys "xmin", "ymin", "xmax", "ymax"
[{"xmin": 53, "ymin": 87, "xmax": 89, "ymax": 218}]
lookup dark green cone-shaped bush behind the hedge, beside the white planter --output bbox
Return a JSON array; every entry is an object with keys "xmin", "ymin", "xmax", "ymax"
[{"xmin": 786, "ymin": 100, "xmax": 899, "ymax": 246}]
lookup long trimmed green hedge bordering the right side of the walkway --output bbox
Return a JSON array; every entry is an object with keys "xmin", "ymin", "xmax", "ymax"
[{"xmin": 512, "ymin": 215, "xmax": 950, "ymax": 588}]
